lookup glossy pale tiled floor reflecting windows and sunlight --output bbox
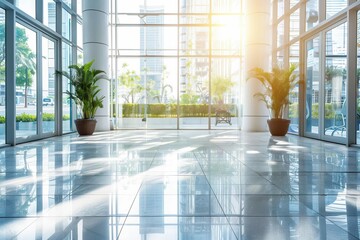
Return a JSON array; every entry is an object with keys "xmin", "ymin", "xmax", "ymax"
[{"xmin": 0, "ymin": 130, "xmax": 360, "ymax": 240}]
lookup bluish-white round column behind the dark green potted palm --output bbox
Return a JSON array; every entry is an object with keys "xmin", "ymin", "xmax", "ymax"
[{"xmin": 82, "ymin": 0, "xmax": 110, "ymax": 131}]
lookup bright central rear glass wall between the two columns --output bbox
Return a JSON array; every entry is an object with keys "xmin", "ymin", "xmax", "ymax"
[{"xmin": 110, "ymin": 0, "xmax": 244, "ymax": 129}]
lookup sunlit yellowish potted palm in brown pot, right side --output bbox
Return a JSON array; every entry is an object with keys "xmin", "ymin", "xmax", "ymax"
[{"xmin": 248, "ymin": 64, "xmax": 300, "ymax": 136}]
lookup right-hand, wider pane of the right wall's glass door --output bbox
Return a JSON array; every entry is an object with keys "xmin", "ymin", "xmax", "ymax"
[{"xmin": 324, "ymin": 23, "xmax": 347, "ymax": 138}]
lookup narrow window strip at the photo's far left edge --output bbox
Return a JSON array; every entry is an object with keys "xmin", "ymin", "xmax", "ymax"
[{"xmin": 0, "ymin": 8, "xmax": 6, "ymax": 144}]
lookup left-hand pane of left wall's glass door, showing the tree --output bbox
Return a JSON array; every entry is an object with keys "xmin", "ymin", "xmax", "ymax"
[{"xmin": 16, "ymin": 23, "xmax": 37, "ymax": 137}]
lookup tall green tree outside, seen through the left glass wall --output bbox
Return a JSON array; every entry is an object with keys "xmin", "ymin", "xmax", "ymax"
[{"xmin": 0, "ymin": 24, "xmax": 36, "ymax": 107}]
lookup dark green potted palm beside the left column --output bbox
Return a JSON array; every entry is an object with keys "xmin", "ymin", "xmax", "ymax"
[{"xmin": 56, "ymin": 60, "xmax": 106, "ymax": 135}]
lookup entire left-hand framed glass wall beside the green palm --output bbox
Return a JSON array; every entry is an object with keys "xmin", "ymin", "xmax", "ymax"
[{"xmin": 0, "ymin": 0, "xmax": 82, "ymax": 145}]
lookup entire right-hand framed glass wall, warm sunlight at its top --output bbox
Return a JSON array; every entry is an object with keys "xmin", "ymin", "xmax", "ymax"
[{"xmin": 272, "ymin": 0, "xmax": 359, "ymax": 144}]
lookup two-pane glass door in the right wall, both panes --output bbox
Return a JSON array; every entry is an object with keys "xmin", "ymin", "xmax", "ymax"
[{"xmin": 304, "ymin": 22, "xmax": 347, "ymax": 143}]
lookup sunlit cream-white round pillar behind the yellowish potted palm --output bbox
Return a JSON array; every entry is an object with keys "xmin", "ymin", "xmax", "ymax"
[{"xmin": 242, "ymin": 0, "xmax": 272, "ymax": 132}]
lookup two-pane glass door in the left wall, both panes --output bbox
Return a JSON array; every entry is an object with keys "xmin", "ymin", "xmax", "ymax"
[{"xmin": 16, "ymin": 23, "xmax": 56, "ymax": 142}]
